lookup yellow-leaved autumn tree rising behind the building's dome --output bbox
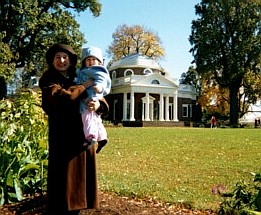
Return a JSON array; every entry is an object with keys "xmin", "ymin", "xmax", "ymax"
[{"xmin": 107, "ymin": 25, "xmax": 164, "ymax": 61}]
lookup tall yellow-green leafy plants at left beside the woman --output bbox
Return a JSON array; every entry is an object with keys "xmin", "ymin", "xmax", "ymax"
[{"xmin": 0, "ymin": 90, "xmax": 48, "ymax": 205}]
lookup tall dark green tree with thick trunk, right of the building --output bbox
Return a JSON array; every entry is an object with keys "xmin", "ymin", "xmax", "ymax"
[{"xmin": 189, "ymin": 0, "xmax": 261, "ymax": 126}]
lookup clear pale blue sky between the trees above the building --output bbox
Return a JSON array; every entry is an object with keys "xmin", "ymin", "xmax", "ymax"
[{"xmin": 76, "ymin": 0, "xmax": 200, "ymax": 79}]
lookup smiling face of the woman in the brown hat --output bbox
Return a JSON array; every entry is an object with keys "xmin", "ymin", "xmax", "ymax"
[{"xmin": 53, "ymin": 52, "xmax": 71, "ymax": 72}]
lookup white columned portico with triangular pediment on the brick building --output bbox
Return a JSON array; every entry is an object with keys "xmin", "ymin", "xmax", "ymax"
[{"xmin": 109, "ymin": 74, "xmax": 178, "ymax": 121}]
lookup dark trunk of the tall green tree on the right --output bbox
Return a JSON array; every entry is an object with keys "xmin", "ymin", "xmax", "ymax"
[{"xmin": 229, "ymin": 83, "xmax": 239, "ymax": 127}]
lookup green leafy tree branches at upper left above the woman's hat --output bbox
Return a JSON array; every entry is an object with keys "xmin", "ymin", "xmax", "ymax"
[{"xmin": 0, "ymin": 0, "xmax": 101, "ymax": 95}]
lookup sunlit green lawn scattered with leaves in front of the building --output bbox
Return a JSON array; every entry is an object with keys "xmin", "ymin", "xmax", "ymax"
[{"xmin": 98, "ymin": 127, "xmax": 261, "ymax": 210}]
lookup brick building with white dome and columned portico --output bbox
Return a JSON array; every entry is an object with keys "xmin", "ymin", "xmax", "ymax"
[{"xmin": 106, "ymin": 54, "xmax": 197, "ymax": 126}]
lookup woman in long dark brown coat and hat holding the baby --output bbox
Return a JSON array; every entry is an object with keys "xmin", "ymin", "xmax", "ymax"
[{"xmin": 39, "ymin": 44, "xmax": 108, "ymax": 215}]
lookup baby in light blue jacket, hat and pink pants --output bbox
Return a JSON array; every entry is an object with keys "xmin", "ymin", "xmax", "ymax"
[{"xmin": 77, "ymin": 46, "xmax": 111, "ymax": 153}]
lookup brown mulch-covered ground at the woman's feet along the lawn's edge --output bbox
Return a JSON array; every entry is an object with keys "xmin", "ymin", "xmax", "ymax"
[{"xmin": 0, "ymin": 192, "xmax": 216, "ymax": 215}]
